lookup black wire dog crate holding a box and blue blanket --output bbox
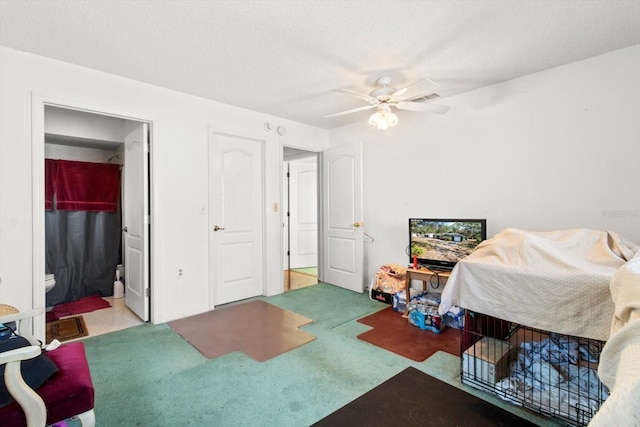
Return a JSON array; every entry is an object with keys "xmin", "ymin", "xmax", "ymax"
[{"xmin": 460, "ymin": 310, "xmax": 609, "ymax": 426}]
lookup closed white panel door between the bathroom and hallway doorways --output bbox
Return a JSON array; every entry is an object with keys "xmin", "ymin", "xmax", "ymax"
[{"xmin": 209, "ymin": 131, "xmax": 264, "ymax": 306}]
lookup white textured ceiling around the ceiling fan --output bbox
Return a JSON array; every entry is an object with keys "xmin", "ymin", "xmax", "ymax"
[{"xmin": 0, "ymin": 0, "xmax": 640, "ymax": 129}]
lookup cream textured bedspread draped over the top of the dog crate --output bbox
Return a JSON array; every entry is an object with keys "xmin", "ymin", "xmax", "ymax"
[{"xmin": 440, "ymin": 228, "xmax": 640, "ymax": 341}]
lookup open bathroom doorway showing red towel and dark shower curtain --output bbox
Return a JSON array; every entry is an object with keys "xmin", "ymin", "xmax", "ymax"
[{"xmin": 38, "ymin": 105, "xmax": 149, "ymax": 335}]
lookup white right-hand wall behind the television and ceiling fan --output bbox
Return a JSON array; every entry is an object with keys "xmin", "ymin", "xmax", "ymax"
[{"xmin": 329, "ymin": 45, "xmax": 640, "ymax": 281}]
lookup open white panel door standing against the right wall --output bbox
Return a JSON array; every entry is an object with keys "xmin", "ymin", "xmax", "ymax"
[{"xmin": 322, "ymin": 145, "xmax": 364, "ymax": 292}]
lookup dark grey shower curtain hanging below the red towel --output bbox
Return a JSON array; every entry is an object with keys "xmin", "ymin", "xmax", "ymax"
[{"xmin": 45, "ymin": 199, "xmax": 121, "ymax": 306}]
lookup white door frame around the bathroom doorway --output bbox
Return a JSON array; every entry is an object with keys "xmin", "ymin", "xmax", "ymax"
[{"xmin": 31, "ymin": 92, "xmax": 161, "ymax": 342}]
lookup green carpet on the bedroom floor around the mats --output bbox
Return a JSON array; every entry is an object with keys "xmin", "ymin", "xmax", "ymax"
[{"xmin": 84, "ymin": 284, "xmax": 553, "ymax": 426}]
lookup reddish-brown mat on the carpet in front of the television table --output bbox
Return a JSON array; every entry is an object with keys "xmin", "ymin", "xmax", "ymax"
[{"xmin": 358, "ymin": 307, "xmax": 460, "ymax": 362}]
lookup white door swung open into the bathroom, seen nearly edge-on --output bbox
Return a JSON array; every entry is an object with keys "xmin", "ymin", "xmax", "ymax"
[{"xmin": 122, "ymin": 122, "xmax": 149, "ymax": 322}]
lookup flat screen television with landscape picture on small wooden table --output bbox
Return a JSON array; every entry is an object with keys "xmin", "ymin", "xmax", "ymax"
[{"xmin": 408, "ymin": 218, "xmax": 487, "ymax": 270}]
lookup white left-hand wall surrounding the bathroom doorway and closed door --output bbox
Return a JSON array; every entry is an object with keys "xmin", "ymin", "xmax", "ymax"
[{"xmin": 0, "ymin": 47, "xmax": 328, "ymax": 322}]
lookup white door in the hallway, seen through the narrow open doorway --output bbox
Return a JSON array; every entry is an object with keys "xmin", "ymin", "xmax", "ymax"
[{"xmin": 289, "ymin": 156, "xmax": 318, "ymax": 268}]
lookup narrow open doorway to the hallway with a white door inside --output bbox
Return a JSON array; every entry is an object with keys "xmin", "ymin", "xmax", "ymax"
[{"xmin": 283, "ymin": 147, "xmax": 319, "ymax": 292}]
